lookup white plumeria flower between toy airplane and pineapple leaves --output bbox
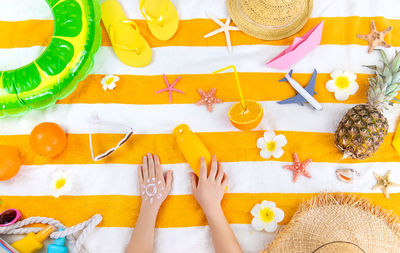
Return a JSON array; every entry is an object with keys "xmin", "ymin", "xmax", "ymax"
[{"xmin": 326, "ymin": 70, "xmax": 358, "ymax": 100}]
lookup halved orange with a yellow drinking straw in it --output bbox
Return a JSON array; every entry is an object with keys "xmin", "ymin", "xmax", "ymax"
[{"xmin": 228, "ymin": 100, "xmax": 263, "ymax": 130}]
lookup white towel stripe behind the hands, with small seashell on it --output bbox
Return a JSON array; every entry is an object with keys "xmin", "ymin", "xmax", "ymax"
[{"xmin": 0, "ymin": 162, "xmax": 400, "ymax": 196}]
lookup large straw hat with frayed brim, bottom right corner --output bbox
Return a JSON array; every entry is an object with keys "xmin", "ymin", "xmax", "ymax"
[{"xmin": 262, "ymin": 193, "xmax": 400, "ymax": 253}]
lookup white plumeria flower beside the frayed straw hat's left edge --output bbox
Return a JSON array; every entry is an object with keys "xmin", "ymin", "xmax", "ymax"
[{"xmin": 250, "ymin": 200, "xmax": 285, "ymax": 232}]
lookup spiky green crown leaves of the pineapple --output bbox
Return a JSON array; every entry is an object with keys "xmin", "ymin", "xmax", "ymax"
[{"xmin": 365, "ymin": 49, "xmax": 400, "ymax": 109}]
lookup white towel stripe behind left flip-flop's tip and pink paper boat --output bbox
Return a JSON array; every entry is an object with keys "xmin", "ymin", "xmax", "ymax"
[{"xmin": 0, "ymin": 45, "xmax": 388, "ymax": 74}]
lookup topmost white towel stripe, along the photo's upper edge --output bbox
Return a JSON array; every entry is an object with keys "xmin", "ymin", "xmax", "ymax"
[{"xmin": 0, "ymin": 0, "xmax": 399, "ymax": 21}]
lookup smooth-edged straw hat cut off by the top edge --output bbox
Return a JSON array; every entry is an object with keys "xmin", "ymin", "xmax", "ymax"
[{"xmin": 226, "ymin": 0, "xmax": 313, "ymax": 40}]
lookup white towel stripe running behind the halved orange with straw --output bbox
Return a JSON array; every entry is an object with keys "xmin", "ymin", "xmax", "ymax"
[{"xmin": 0, "ymin": 102, "xmax": 400, "ymax": 135}]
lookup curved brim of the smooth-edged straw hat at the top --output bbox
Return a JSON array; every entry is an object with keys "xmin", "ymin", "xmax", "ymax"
[{"xmin": 226, "ymin": 0, "xmax": 313, "ymax": 40}]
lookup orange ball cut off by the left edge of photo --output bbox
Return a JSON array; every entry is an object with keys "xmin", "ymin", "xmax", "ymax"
[{"xmin": 0, "ymin": 146, "xmax": 22, "ymax": 181}]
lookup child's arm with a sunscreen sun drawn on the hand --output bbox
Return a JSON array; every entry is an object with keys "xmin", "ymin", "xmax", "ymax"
[{"xmin": 126, "ymin": 154, "xmax": 172, "ymax": 253}]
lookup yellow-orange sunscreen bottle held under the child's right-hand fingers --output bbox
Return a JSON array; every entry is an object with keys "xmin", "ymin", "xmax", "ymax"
[{"xmin": 173, "ymin": 124, "xmax": 211, "ymax": 176}]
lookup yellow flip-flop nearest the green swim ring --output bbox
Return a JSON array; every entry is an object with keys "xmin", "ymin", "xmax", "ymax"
[{"xmin": 101, "ymin": 0, "xmax": 152, "ymax": 67}]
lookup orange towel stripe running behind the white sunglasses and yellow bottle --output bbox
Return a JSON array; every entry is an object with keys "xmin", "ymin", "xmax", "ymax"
[{"xmin": 0, "ymin": 130, "xmax": 400, "ymax": 165}]
